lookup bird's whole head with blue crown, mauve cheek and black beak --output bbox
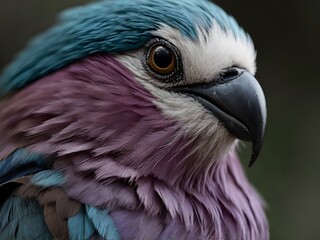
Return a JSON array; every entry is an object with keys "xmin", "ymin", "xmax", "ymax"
[{"xmin": 0, "ymin": 0, "xmax": 266, "ymax": 187}]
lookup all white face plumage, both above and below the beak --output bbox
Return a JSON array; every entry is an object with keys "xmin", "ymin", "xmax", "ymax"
[{"xmin": 117, "ymin": 24, "xmax": 255, "ymax": 164}]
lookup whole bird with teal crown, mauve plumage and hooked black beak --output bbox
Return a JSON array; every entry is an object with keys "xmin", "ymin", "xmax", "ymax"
[{"xmin": 0, "ymin": 0, "xmax": 269, "ymax": 240}]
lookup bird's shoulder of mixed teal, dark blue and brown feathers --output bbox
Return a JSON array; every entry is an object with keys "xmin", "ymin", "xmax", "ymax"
[{"xmin": 0, "ymin": 150, "xmax": 119, "ymax": 240}]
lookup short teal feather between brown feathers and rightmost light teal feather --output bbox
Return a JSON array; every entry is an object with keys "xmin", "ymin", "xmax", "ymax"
[{"xmin": 68, "ymin": 207, "xmax": 95, "ymax": 240}]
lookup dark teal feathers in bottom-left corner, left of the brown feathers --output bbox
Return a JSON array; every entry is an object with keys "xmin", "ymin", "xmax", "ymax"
[{"xmin": 0, "ymin": 197, "xmax": 52, "ymax": 240}]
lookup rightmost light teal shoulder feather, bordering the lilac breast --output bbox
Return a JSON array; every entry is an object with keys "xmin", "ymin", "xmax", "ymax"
[{"xmin": 86, "ymin": 205, "xmax": 120, "ymax": 240}]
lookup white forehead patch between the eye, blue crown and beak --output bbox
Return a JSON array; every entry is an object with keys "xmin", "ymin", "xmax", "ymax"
[{"xmin": 154, "ymin": 23, "xmax": 256, "ymax": 84}]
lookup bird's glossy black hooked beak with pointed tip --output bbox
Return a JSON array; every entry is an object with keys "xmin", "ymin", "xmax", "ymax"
[{"xmin": 179, "ymin": 68, "xmax": 267, "ymax": 166}]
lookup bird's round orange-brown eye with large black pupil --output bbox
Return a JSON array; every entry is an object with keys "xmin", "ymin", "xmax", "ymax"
[{"xmin": 147, "ymin": 44, "xmax": 177, "ymax": 75}]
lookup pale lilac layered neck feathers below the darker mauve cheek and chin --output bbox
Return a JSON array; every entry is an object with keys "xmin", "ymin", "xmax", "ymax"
[{"xmin": 59, "ymin": 145, "xmax": 268, "ymax": 240}]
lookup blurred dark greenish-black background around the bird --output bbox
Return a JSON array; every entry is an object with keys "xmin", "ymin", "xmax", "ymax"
[{"xmin": 0, "ymin": 0, "xmax": 320, "ymax": 240}]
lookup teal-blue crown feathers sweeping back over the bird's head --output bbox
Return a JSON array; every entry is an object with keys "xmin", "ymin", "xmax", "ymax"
[{"xmin": 0, "ymin": 0, "xmax": 248, "ymax": 96}]
